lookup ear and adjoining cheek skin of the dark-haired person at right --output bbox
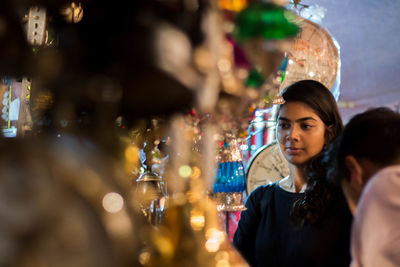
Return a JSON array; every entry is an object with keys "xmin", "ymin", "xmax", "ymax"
[{"xmin": 342, "ymin": 155, "xmax": 364, "ymax": 215}]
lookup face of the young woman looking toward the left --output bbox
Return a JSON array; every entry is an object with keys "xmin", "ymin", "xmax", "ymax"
[{"xmin": 277, "ymin": 102, "xmax": 325, "ymax": 166}]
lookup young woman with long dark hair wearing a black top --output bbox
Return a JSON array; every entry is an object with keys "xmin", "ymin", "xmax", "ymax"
[{"xmin": 233, "ymin": 80, "xmax": 352, "ymax": 267}]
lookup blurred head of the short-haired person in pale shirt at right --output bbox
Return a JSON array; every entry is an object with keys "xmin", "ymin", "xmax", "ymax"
[{"xmin": 326, "ymin": 107, "xmax": 400, "ymax": 214}]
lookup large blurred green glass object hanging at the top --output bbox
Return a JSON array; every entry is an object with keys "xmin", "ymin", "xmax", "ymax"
[{"xmin": 234, "ymin": 3, "xmax": 299, "ymax": 42}]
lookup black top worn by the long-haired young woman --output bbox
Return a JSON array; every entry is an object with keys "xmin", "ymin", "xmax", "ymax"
[{"xmin": 233, "ymin": 183, "xmax": 352, "ymax": 267}]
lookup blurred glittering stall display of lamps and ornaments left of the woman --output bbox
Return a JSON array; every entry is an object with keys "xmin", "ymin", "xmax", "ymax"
[{"xmin": 0, "ymin": 0, "xmax": 340, "ymax": 267}]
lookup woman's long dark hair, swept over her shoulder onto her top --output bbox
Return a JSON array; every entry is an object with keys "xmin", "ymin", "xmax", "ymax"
[{"xmin": 282, "ymin": 80, "xmax": 343, "ymax": 225}]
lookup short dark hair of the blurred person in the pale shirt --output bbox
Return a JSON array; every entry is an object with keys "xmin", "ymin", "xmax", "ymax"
[{"xmin": 324, "ymin": 107, "xmax": 400, "ymax": 184}]
